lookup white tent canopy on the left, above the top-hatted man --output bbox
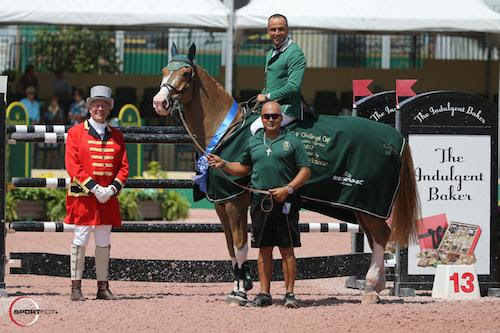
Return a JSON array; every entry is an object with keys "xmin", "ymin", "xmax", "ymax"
[{"xmin": 0, "ymin": 0, "xmax": 229, "ymax": 30}]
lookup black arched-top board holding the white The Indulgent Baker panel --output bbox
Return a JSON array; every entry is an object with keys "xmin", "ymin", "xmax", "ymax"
[{"xmin": 400, "ymin": 91, "xmax": 498, "ymax": 287}]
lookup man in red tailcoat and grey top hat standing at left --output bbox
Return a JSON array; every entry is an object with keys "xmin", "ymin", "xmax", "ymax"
[{"xmin": 64, "ymin": 86, "xmax": 129, "ymax": 301}]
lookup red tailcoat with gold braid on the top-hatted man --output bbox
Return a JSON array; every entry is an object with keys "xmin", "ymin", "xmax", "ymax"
[{"xmin": 64, "ymin": 121, "xmax": 128, "ymax": 226}]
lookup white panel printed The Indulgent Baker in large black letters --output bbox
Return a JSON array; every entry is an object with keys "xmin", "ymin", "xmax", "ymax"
[{"xmin": 408, "ymin": 134, "xmax": 491, "ymax": 275}]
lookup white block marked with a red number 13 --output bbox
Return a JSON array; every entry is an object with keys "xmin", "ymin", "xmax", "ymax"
[{"xmin": 432, "ymin": 265, "xmax": 481, "ymax": 299}]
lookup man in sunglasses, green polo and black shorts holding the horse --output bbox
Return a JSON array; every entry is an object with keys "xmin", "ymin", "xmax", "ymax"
[{"xmin": 208, "ymin": 101, "xmax": 311, "ymax": 308}]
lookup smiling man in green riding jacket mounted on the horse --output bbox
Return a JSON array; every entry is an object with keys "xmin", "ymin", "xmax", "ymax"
[{"xmin": 250, "ymin": 14, "xmax": 306, "ymax": 134}]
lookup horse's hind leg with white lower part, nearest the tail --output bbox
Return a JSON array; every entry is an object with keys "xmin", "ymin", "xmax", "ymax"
[{"xmin": 356, "ymin": 213, "xmax": 391, "ymax": 304}]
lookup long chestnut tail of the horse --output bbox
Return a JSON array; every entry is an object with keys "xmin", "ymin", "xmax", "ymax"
[{"xmin": 391, "ymin": 141, "xmax": 420, "ymax": 247}]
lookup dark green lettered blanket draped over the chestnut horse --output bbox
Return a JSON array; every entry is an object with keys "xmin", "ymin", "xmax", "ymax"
[{"xmin": 207, "ymin": 115, "xmax": 405, "ymax": 222}]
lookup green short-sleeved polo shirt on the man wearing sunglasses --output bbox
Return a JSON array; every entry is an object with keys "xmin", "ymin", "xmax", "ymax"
[{"xmin": 240, "ymin": 130, "xmax": 311, "ymax": 190}]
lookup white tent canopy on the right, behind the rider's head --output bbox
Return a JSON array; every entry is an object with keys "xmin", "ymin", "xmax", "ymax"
[{"xmin": 235, "ymin": 0, "xmax": 500, "ymax": 33}]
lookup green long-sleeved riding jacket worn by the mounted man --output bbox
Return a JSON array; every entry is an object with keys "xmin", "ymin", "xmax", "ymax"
[{"xmin": 262, "ymin": 42, "xmax": 306, "ymax": 119}]
